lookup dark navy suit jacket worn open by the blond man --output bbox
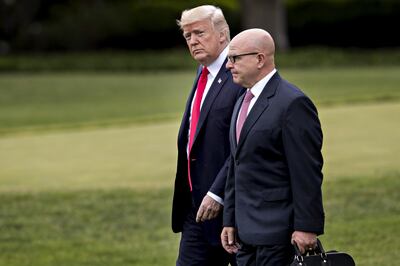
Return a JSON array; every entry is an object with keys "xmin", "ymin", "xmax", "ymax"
[{"xmin": 172, "ymin": 62, "xmax": 244, "ymax": 243}]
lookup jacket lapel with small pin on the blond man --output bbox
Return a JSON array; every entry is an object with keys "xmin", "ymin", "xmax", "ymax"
[{"xmin": 193, "ymin": 62, "xmax": 228, "ymax": 148}]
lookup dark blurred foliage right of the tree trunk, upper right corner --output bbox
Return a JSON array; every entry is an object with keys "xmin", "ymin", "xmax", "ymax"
[{"xmin": 286, "ymin": 0, "xmax": 400, "ymax": 48}]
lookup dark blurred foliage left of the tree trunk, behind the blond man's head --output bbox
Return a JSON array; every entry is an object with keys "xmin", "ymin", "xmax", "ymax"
[{"xmin": 0, "ymin": 0, "xmax": 238, "ymax": 53}]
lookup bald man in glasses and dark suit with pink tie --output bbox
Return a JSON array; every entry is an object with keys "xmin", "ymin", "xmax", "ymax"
[{"xmin": 221, "ymin": 29, "xmax": 324, "ymax": 266}]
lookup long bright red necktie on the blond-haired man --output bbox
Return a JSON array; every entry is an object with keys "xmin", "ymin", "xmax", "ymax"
[{"xmin": 188, "ymin": 67, "xmax": 209, "ymax": 191}]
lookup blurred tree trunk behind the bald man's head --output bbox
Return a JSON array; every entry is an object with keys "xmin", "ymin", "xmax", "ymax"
[{"xmin": 240, "ymin": 0, "xmax": 289, "ymax": 51}]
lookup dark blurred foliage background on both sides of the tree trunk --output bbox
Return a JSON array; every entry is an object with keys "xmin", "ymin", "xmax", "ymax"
[{"xmin": 0, "ymin": 0, "xmax": 400, "ymax": 54}]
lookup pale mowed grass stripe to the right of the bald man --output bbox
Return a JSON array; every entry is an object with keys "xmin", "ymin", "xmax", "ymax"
[{"xmin": 319, "ymin": 103, "xmax": 400, "ymax": 181}]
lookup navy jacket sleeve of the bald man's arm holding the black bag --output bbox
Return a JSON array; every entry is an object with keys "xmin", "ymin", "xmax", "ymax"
[{"xmin": 283, "ymin": 96, "xmax": 324, "ymax": 234}]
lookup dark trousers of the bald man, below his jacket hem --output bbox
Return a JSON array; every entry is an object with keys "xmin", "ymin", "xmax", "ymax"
[{"xmin": 236, "ymin": 243, "xmax": 294, "ymax": 266}]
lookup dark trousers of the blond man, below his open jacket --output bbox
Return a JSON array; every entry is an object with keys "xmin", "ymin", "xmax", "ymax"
[{"xmin": 176, "ymin": 208, "xmax": 236, "ymax": 266}]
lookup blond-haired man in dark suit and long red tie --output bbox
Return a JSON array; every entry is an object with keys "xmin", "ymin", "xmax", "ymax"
[{"xmin": 172, "ymin": 5, "xmax": 244, "ymax": 266}]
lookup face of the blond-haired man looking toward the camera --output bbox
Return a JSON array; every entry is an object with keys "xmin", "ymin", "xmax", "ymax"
[{"xmin": 182, "ymin": 20, "xmax": 225, "ymax": 66}]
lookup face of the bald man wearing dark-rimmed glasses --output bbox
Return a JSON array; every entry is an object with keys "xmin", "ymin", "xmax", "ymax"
[{"xmin": 226, "ymin": 40, "xmax": 258, "ymax": 88}]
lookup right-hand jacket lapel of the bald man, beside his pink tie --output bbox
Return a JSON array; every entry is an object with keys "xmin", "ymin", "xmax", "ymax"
[{"xmin": 235, "ymin": 73, "xmax": 281, "ymax": 156}]
